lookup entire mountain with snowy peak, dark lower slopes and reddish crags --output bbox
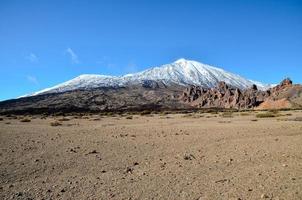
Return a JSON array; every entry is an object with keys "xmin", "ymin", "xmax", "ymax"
[{"xmin": 0, "ymin": 59, "xmax": 302, "ymax": 114}]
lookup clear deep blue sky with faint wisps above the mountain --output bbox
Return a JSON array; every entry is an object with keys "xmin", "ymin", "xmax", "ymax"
[{"xmin": 0, "ymin": 0, "xmax": 302, "ymax": 101}]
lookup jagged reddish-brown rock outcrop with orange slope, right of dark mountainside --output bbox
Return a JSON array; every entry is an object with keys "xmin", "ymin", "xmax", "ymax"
[{"xmin": 181, "ymin": 79, "xmax": 302, "ymax": 109}]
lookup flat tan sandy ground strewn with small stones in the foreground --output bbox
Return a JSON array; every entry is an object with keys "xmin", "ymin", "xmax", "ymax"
[{"xmin": 0, "ymin": 111, "xmax": 302, "ymax": 200}]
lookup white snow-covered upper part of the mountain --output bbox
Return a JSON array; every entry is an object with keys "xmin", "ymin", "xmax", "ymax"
[{"xmin": 28, "ymin": 59, "xmax": 270, "ymax": 95}]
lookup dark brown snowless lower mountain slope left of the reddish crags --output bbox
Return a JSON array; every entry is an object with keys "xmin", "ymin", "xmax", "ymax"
[{"xmin": 0, "ymin": 85, "xmax": 189, "ymax": 115}]
